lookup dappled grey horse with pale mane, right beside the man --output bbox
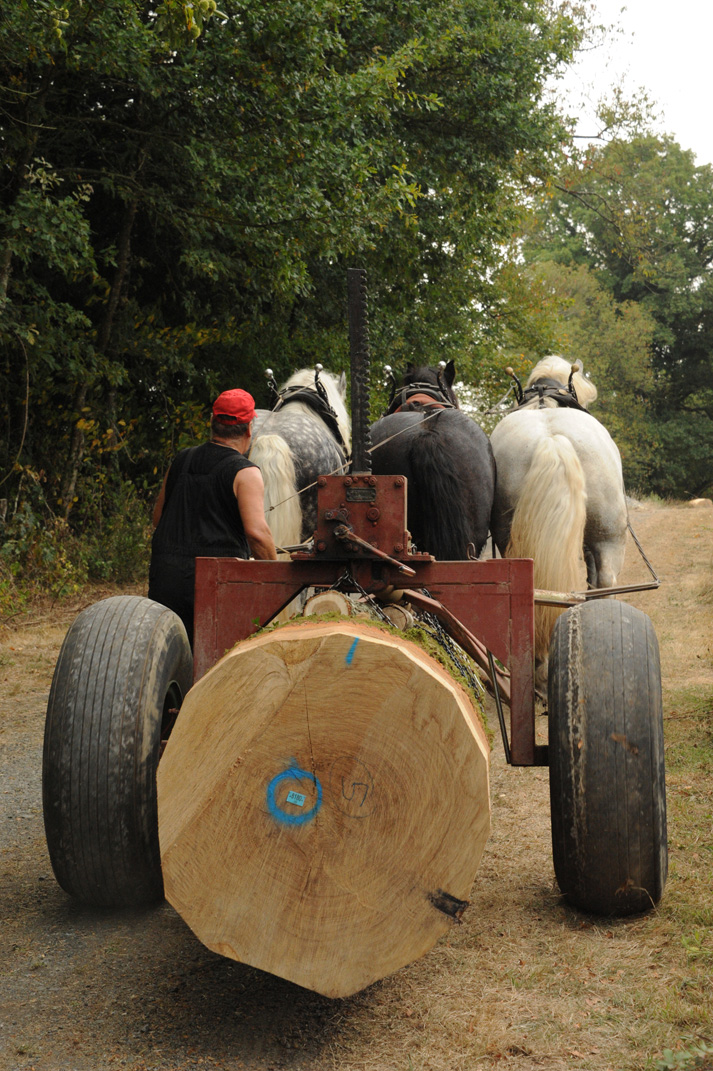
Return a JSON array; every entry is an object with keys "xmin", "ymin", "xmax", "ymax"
[{"xmin": 248, "ymin": 365, "xmax": 351, "ymax": 549}]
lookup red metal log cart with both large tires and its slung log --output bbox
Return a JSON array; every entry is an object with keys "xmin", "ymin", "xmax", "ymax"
[{"xmin": 43, "ymin": 272, "xmax": 666, "ymax": 997}]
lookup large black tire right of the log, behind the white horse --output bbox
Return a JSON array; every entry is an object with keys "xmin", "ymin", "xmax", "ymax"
[{"xmin": 548, "ymin": 599, "xmax": 668, "ymax": 916}]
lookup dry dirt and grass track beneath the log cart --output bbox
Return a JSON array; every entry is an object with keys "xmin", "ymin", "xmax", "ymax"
[{"xmin": 0, "ymin": 507, "xmax": 713, "ymax": 1071}]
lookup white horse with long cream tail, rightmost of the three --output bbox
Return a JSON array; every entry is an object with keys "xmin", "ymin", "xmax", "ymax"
[{"xmin": 490, "ymin": 357, "xmax": 628, "ymax": 683}]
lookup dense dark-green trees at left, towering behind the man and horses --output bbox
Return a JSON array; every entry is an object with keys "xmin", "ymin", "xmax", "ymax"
[{"xmin": 0, "ymin": 0, "xmax": 579, "ymax": 565}]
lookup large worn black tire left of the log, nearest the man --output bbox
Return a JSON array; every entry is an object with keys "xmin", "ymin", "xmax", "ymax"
[{"xmin": 42, "ymin": 595, "xmax": 193, "ymax": 907}]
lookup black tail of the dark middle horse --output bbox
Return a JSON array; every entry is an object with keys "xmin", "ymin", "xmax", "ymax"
[{"xmin": 408, "ymin": 417, "xmax": 473, "ymax": 561}]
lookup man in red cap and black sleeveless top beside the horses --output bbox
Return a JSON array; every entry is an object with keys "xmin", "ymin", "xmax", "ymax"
[{"xmin": 149, "ymin": 390, "xmax": 277, "ymax": 644}]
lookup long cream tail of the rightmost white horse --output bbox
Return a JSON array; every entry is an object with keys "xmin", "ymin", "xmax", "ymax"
[{"xmin": 505, "ymin": 435, "xmax": 587, "ymax": 662}]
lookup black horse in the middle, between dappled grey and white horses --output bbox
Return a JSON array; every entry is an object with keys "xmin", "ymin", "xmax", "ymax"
[{"xmin": 370, "ymin": 361, "xmax": 496, "ymax": 561}]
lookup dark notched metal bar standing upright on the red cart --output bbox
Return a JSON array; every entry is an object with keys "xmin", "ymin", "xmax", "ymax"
[{"xmin": 347, "ymin": 268, "xmax": 371, "ymax": 472}]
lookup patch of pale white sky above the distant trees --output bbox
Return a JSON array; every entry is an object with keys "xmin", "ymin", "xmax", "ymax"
[{"xmin": 557, "ymin": 0, "xmax": 713, "ymax": 165}]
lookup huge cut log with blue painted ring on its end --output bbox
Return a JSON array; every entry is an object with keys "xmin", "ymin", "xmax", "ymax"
[{"xmin": 158, "ymin": 619, "xmax": 490, "ymax": 997}]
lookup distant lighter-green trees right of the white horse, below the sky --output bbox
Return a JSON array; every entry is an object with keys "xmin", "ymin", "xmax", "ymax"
[{"xmin": 525, "ymin": 133, "xmax": 713, "ymax": 497}]
